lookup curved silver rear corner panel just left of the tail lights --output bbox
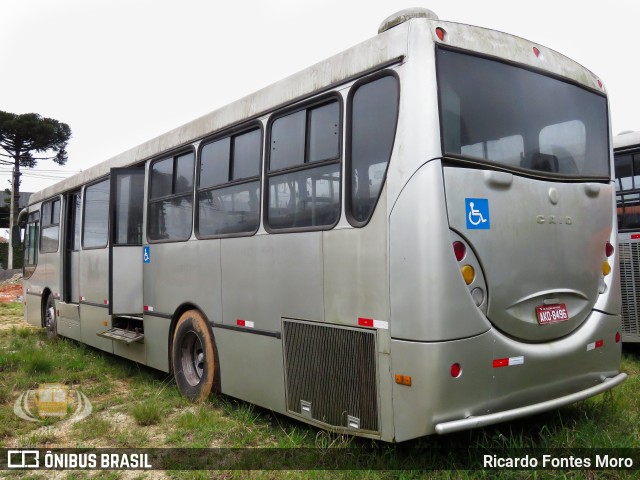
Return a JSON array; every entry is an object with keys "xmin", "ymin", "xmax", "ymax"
[{"xmin": 389, "ymin": 160, "xmax": 490, "ymax": 341}]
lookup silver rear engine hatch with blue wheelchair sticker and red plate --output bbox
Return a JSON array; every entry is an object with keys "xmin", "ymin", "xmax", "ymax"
[{"xmin": 443, "ymin": 167, "xmax": 614, "ymax": 342}]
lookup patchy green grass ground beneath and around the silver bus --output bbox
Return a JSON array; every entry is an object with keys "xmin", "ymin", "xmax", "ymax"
[{"xmin": 0, "ymin": 304, "xmax": 640, "ymax": 479}]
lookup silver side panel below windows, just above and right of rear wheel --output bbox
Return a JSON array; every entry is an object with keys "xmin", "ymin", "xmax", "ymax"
[{"xmin": 222, "ymin": 232, "xmax": 324, "ymax": 330}]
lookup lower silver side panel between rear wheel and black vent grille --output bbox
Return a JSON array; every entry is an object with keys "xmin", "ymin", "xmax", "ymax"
[{"xmin": 213, "ymin": 328, "xmax": 286, "ymax": 413}]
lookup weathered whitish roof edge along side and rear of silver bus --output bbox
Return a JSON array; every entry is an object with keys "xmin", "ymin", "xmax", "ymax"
[{"xmin": 30, "ymin": 9, "xmax": 605, "ymax": 204}]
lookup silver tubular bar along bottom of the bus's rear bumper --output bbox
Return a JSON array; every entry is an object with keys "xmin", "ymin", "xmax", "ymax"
[{"xmin": 435, "ymin": 373, "xmax": 627, "ymax": 434}]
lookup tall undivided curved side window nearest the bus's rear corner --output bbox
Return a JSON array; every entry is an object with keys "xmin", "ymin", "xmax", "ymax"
[{"xmin": 347, "ymin": 75, "xmax": 399, "ymax": 227}]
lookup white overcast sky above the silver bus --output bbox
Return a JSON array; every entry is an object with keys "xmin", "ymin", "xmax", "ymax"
[{"xmin": 0, "ymin": 0, "xmax": 640, "ymax": 191}]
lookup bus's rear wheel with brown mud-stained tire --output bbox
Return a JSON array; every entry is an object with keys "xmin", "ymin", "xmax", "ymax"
[{"xmin": 171, "ymin": 310, "xmax": 216, "ymax": 403}]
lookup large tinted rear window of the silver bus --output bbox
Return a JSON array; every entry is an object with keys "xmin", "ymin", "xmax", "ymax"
[{"xmin": 437, "ymin": 48, "xmax": 610, "ymax": 179}]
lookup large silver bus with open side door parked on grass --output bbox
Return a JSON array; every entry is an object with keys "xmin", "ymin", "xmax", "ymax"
[{"xmin": 15, "ymin": 9, "xmax": 626, "ymax": 442}]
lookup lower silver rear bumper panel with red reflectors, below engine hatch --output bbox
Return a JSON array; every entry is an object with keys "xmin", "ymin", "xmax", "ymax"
[{"xmin": 391, "ymin": 311, "xmax": 621, "ymax": 442}]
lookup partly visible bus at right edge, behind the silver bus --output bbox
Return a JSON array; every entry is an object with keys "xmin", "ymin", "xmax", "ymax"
[{"xmin": 613, "ymin": 132, "xmax": 640, "ymax": 342}]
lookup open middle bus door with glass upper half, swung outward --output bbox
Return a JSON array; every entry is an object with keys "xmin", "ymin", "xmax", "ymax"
[{"xmin": 109, "ymin": 167, "xmax": 144, "ymax": 315}]
